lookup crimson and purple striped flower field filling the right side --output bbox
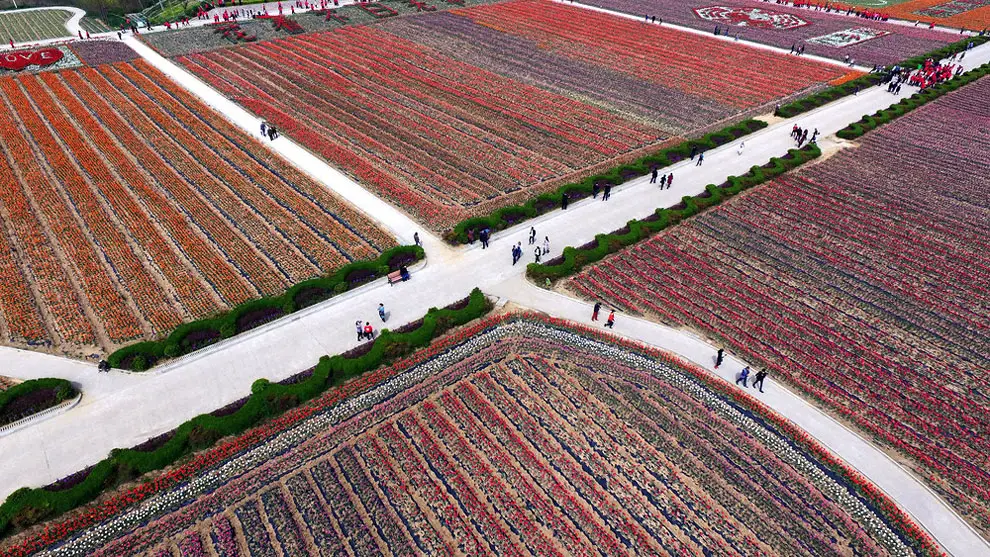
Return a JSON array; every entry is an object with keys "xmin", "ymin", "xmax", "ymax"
[{"xmin": 567, "ymin": 78, "xmax": 990, "ymax": 532}]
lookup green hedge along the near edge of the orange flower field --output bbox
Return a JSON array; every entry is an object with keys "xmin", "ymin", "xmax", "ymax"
[{"xmin": 107, "ymin": 246, "xmax": 426, "ymax": 371}]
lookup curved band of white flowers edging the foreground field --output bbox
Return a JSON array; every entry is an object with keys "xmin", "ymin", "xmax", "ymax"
[{"xmin": 39, "ymin": 319, "xmax": 914, "ymax": 557}]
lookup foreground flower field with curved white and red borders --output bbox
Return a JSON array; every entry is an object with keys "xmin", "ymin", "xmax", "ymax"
[{"xmin": 0, "ymin": 315, "xmax": 938, "ymax": 556}]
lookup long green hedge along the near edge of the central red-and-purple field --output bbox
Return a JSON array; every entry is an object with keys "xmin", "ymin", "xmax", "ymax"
[{"xmin": 444, "ymin": 119, "xmax": 767, "ymax": 244}]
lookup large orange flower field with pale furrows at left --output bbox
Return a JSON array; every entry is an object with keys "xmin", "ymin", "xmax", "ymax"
[{"xmin": 0, "ymin": 54, "xmax": 394, "ymax": 355}]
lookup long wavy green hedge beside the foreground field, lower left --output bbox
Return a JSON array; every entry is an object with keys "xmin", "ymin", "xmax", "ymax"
[{"xmin": 0, "ymin": 288, "xmax": 492, "ymax": 536}]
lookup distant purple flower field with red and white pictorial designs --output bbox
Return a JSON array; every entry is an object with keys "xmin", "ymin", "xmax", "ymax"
[{"xmin": 594, "ymin": 0, "xmax": 959, "ymax": 66}]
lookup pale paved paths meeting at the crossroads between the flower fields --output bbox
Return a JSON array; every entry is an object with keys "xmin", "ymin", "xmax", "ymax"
[{"xmin": 0, "ymin": 17, "xmax": 990, "ymax": 556}]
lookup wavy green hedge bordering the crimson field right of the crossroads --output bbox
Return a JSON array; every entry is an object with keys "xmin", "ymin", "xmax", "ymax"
[{"xmin": 526, "ymin": 143, "xmax": 821, "ymax": 283}]
